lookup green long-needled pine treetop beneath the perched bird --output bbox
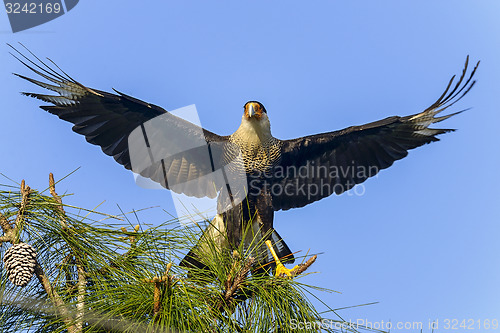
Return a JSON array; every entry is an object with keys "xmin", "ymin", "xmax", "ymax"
[{"xmin": 0, "ymin": 174, "xmax": 376, "ymax": 333}]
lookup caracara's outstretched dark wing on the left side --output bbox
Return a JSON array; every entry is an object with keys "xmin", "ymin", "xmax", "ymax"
[{"xmin": 11, "ymin": 46, "xmax": 229, "ymax": 198}]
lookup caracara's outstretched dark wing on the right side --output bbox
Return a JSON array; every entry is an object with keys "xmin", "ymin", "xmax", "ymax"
[{"xmin": 268, "ymin": 57, "xmax": 479, "ymax": 210}]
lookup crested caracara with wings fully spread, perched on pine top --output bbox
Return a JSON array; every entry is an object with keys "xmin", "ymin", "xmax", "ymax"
[{"xmin": 12, "ymin": 45, "xmax": 479, "ymax": 275}]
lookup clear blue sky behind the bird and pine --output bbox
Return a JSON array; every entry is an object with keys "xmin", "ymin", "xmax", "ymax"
[{"xmin": 0, "ymin": 0, "xmax": 500, "ymax": 332}]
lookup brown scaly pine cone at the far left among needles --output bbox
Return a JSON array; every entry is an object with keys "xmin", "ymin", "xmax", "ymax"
[{"xmin": 3, "ymin": 243, "xmax": 36, "ymax": 287}]
